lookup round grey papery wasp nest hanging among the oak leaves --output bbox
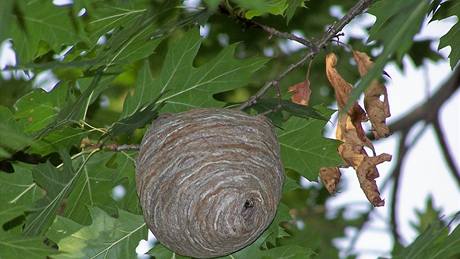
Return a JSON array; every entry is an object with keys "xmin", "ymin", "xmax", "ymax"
[{"xmin": 136, "ymin": 109, "xmax": 284, "ymax": 258}]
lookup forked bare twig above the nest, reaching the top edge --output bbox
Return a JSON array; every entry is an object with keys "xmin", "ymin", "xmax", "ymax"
[{"xmin": 221, "ymin": 0, "xmax": 372, "ymax": 110}]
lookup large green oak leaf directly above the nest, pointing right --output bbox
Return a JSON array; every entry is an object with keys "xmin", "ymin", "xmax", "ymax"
[{"xmin": 122, "ymin": 29, "xmax": 268, "ymax": 114}]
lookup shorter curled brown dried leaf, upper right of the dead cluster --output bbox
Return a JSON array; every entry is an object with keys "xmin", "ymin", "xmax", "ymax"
[{"xmin": 353, "ymin": 51, "xmax": 391, "ymax": 139}]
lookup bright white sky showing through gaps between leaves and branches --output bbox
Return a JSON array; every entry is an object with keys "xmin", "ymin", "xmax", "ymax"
[{"xmin": 0, "ymin": 2, "xmax": 460, "ymax": 259}]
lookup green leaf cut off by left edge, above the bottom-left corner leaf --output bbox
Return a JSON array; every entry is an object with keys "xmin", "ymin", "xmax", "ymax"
[{"xmin": 0, "ymin": 163, "xmax": 43, "ymax": 234}]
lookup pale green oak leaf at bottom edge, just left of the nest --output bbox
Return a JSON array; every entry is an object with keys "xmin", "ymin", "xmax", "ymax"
[{"xmin": 46, "ymin": 207, "xmax": 147, "ymax": 259}]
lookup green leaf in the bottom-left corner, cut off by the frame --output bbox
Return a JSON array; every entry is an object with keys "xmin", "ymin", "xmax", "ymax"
[{"xmin": 0, "ymin": 233, "xmax": 57, "ymax": 259}]
